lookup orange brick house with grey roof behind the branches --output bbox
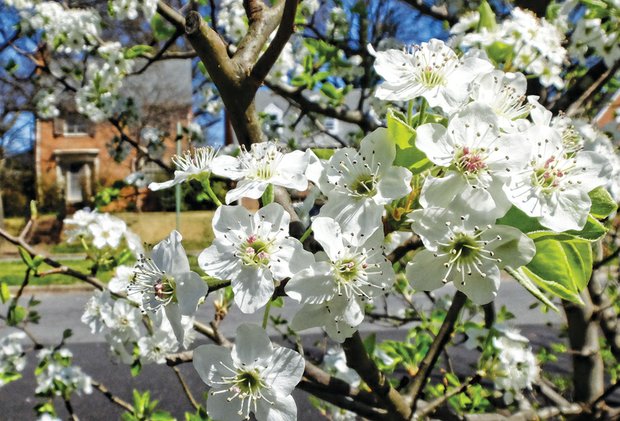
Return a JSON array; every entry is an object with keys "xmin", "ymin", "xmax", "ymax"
[{"xmin": 34, "ymin": 60, "xmax": 192, "ymax": 208}]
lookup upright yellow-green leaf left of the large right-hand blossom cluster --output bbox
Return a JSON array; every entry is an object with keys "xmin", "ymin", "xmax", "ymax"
[{"xmin": 387, "ymin": 110, "xmax": 433, "ymax": 174}]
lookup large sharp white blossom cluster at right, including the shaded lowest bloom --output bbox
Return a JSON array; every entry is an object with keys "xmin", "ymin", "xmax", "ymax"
[{"xmin": 370, "ymin": 40, "xmax": 612, "ymax": 304}]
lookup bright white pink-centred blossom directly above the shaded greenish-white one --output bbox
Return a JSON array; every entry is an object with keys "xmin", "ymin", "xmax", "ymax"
[{"xmin": 416, "ymin": 103, "xmax": 529, "ymax": 222}]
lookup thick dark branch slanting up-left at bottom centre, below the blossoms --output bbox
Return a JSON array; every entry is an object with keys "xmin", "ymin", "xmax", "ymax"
[{"xmin": 342, "ymin": 332, "xmax": 411, "ymax": 420}]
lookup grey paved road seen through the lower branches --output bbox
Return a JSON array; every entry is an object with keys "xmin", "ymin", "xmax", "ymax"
[{"xmin": 0, "ymin": 281, "xmax": 561, "ymax": 421}]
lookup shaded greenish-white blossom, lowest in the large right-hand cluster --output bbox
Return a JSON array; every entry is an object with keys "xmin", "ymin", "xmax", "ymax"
[{"xmin": 406, "ymin": 208, "xmax": 536, "ymax": 305}]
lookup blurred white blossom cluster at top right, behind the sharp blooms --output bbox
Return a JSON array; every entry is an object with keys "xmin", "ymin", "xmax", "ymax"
[{"xmin": 450, "ymin": 7, "xmax": 567, "ymax": 88}]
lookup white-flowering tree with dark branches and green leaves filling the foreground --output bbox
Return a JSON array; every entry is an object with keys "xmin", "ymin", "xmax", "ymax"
[{"xmin": 0, "ymin": 0, "xmax": 620, "ymax": 420}]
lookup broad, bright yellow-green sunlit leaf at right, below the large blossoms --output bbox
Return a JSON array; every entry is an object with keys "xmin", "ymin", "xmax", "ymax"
[{"xmin": 527, "ymin": 231, "xmax": 592, "ymax": 302}]
